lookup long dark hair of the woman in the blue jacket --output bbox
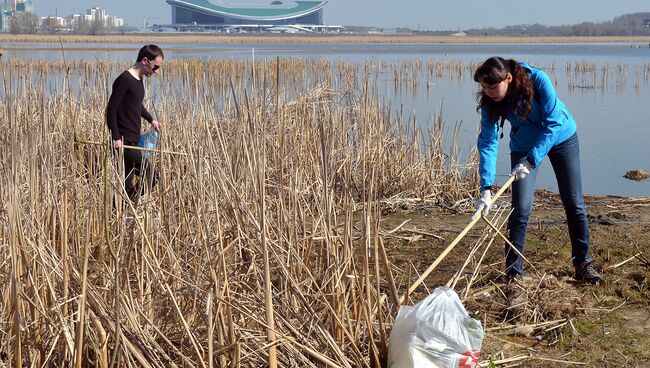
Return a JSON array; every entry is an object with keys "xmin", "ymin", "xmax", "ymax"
[{"xmin": 474, "ymin": 56, "xmax": 535, "ymax": 120}]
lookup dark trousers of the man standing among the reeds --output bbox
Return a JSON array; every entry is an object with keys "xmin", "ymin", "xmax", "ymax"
[{"xmin": 124, "ymin": 141, "xmax": 158, "ymax": 205}]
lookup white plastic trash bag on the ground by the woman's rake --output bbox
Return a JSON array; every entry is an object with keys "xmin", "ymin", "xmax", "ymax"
[{"xmin": 388, "ymin": 287, "xmax": 483, "ymax": 368}]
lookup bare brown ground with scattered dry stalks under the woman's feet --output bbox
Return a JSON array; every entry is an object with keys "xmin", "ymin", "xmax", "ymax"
[{"xmin": 382, "ymin": 192, "xmax": 650, "ymax": 367}]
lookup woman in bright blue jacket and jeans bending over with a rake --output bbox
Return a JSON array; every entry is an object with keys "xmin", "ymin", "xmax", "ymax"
[{"xmin": 474, "ymin": 57, "xmax": 602, "ymax": 283}]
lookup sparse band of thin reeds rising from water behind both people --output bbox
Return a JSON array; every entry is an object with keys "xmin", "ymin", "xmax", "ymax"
[{"xmin": 2, "ymin": 58, "xmax": 650, "ymax": 100}]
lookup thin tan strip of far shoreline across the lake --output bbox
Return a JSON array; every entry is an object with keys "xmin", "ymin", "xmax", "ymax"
[{"xmin": 0, "ymin": 33, "xmax": 650, "ymax": 47}]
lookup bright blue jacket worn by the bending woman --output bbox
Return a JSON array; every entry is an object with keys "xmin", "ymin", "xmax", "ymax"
[{"xmin": 477, "ymin": 63, "xmax": 576, "ymax": 189}]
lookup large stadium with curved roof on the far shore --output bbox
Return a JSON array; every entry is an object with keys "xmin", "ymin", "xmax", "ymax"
[{"xmin": 166, "ymin": 0, "xmax": 327, "ymax": 26}]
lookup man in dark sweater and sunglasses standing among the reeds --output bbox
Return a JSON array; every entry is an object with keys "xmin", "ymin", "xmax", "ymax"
[{"xmin": 106, "ymin": 45, "xmax": 165, "ymax": 205}]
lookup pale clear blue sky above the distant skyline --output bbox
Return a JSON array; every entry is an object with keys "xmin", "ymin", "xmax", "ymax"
[{"xmin": 29, "ymin": 0, "xmax": 650, "ymax": 30}]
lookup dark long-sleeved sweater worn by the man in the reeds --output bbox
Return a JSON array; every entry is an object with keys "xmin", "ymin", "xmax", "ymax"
[{"xmin": 106, "ymin": 70, "xmax": 153, "ymax": 142}]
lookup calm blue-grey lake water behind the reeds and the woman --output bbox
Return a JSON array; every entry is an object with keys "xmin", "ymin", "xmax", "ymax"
[{"xmin": 0, "ymin": 43, "xmax": 650, "ymax": 196}]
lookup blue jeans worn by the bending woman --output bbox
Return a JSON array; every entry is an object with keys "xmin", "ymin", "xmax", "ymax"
[{"xmin": 506, "ymin": 134, "xmax": 591, "ymax": 277}]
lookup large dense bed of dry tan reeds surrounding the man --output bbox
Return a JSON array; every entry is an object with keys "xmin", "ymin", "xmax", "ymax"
[{"xmin": 0, "ymin": 59, "xmax": 477, "ymax": 367}]
